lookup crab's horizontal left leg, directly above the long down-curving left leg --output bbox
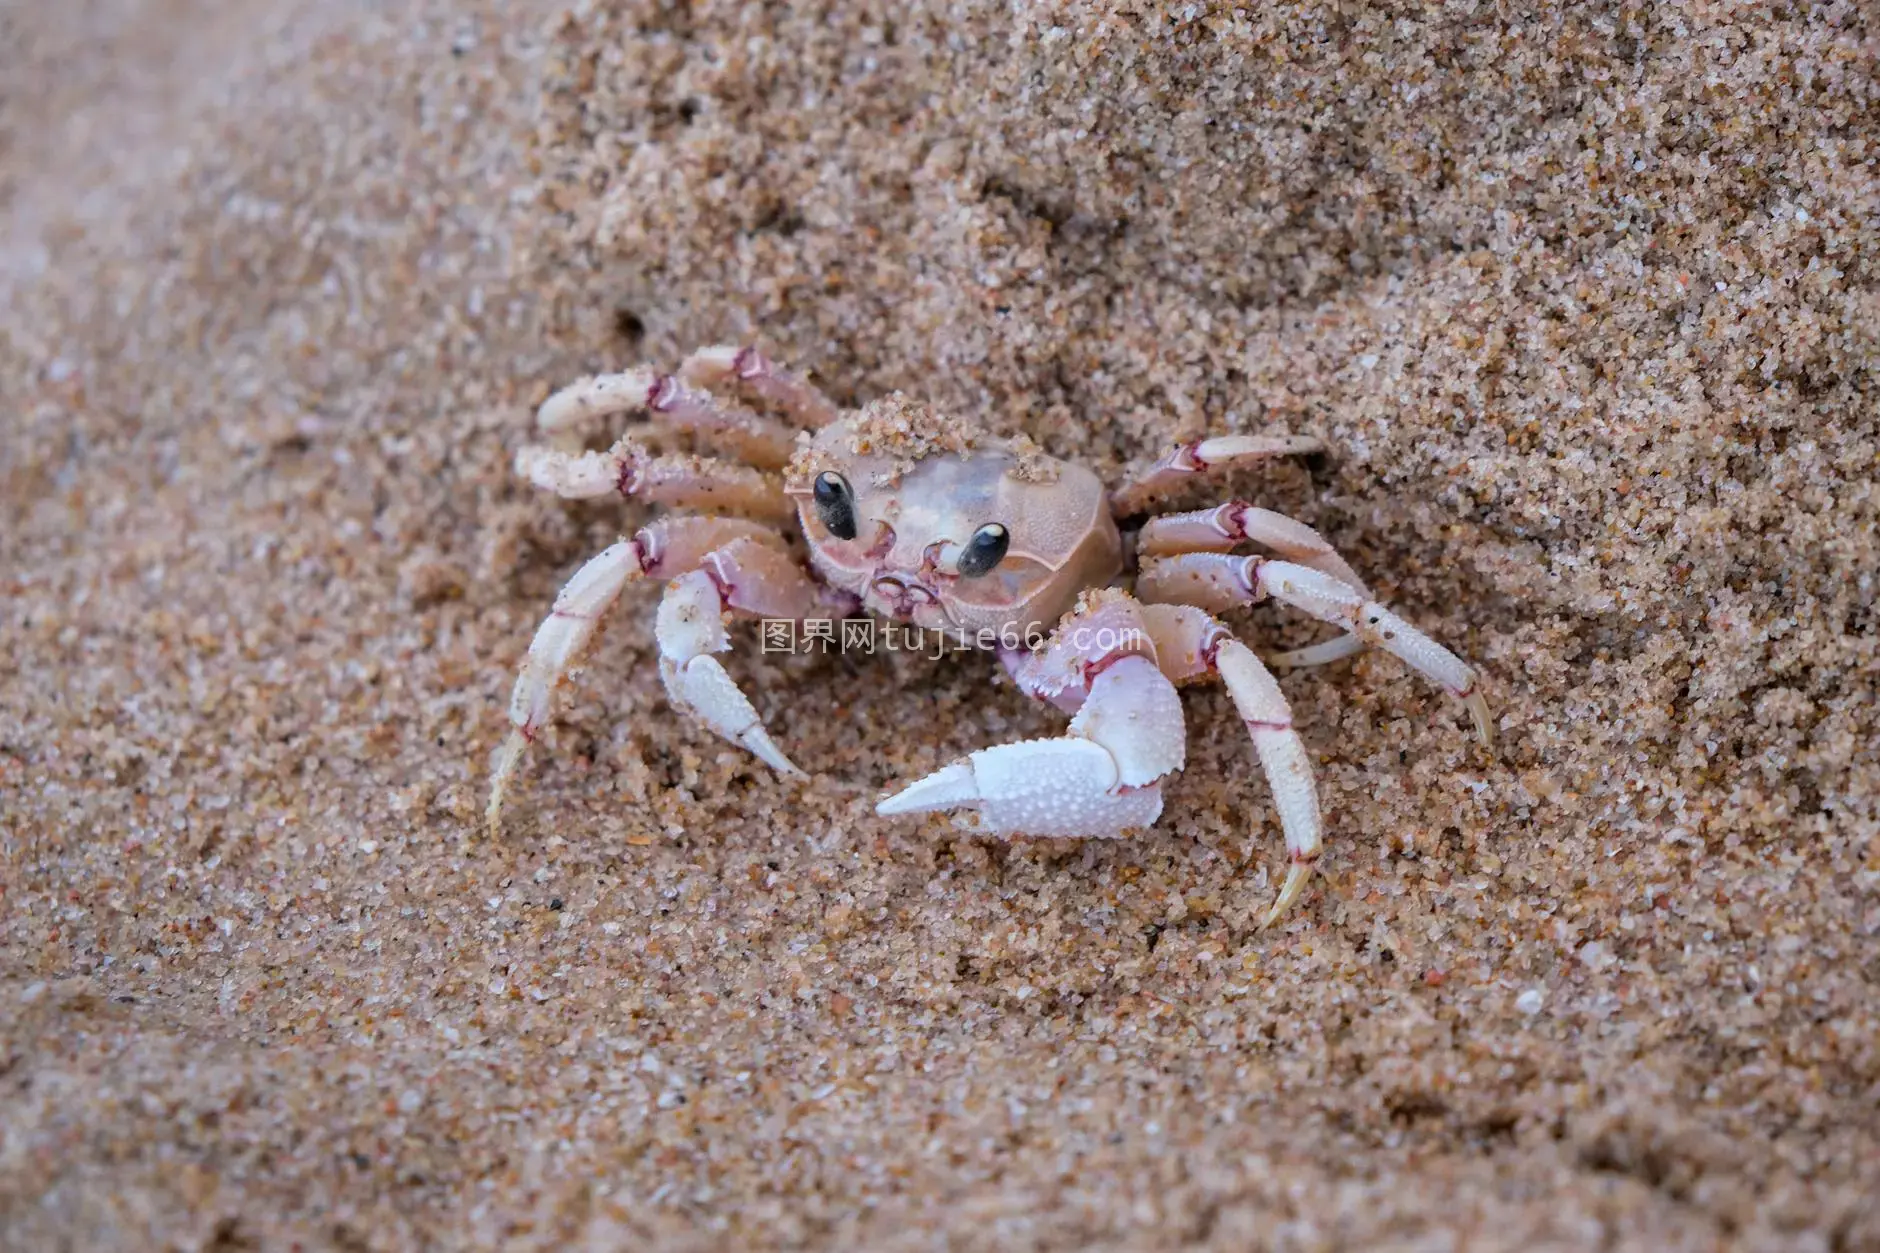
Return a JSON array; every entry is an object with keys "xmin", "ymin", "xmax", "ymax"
[{"xmin": 515, "ymin": 436, "xmax": 795, "ymax": 521}]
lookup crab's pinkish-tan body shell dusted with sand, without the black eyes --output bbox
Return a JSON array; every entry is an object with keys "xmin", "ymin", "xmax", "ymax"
[{"xmin": 784, "ymin": 395, "xmax": 1122, "ymax": 647}]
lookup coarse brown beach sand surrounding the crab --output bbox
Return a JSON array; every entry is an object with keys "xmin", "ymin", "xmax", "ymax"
[{"xmin": 0, "ymin": 0, "xmax": 1880, "ymax": 1249}]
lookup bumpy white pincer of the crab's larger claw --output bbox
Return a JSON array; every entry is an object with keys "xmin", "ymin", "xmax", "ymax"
[{"xmin": 874, "ymin": 738, "xmax": 1162, "ymax": 839}]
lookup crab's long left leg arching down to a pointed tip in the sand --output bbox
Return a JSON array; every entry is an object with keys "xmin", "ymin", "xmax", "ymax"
[{"xmin": 485, "ymin": 517, "xmax": 807, "ymax": 833}]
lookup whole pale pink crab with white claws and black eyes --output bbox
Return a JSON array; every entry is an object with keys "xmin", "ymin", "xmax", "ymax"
[{"xmin": 487, "ymin": 346, "xmax": 1491, "ymax": 926}]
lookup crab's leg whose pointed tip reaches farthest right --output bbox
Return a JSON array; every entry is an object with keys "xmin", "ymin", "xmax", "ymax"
[{"xmin": 1136, "ymin": 553, "xmax": 1493, "ymax": 743}]
